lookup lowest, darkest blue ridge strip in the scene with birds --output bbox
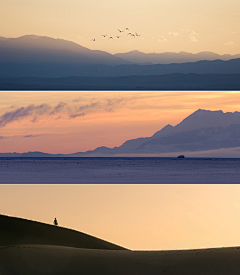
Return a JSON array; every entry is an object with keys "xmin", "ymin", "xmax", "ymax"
[{"xmin": 0, "ymin": 73, "xmax": 240, "ymax": 91}]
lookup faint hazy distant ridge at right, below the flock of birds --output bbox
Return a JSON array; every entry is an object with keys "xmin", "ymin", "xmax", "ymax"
[{"xmin": 114, "ymin": 50, "xmax": 240, "ymax": 64}]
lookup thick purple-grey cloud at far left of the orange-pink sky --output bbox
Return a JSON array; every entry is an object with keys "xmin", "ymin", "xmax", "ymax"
[{"xmin": 0, "ymin": 104, "xmax": 51, "ymax": 128}]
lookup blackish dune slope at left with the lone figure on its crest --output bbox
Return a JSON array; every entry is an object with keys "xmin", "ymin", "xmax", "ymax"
[{"xmin": 0, "ymin": 215, "xmax": 127, "ymax": 250}]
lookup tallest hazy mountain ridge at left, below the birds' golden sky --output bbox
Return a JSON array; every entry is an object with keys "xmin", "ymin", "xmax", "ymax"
[{"xmin": 0, "ymin": 35, "xmax": 131, "ymax": 65}]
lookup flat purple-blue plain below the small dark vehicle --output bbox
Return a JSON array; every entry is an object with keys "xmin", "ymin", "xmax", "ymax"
[{"xmin": 0, "ymin": 158, "xmax": 240, "ymax": 183}]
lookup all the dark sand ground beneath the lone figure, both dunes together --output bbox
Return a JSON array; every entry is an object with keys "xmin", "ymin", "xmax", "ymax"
[{"xmin": 0, "ymin": 215, "xmax": 240, "ymax": 275}]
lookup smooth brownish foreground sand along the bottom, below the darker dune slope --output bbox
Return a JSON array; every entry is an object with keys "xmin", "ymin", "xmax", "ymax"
[{"xmin": 0, "ymin": 245, "xmax": 240, "ymax": 275}]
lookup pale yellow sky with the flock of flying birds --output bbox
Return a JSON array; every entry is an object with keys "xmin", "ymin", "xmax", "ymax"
[{"xmin": 0, "ymin": 0, "xmax": 240, "ymax": 54}]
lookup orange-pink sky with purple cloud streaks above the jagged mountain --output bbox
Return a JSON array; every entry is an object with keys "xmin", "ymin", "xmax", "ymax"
[{"xmin": 0, "ymin": 91, "xmax": 240, "ymax": 153}]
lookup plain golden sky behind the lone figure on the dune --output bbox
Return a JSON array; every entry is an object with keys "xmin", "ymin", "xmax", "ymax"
[{"xmin": 0, "ymin": 184, "xmax": 240, "ymax": 250}]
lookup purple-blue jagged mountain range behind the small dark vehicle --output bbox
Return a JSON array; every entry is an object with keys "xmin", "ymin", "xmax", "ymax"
[{"xmin": 0, "ymin": 109, "xmax": 240, "ymax": 157}]
